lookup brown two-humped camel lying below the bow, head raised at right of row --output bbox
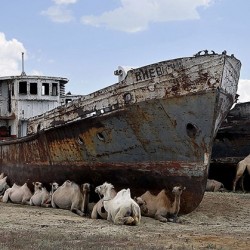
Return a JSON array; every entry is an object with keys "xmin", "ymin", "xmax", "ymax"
[{"xmin": 134, "ymin": 186, "xmax": 186, "ymax": 222}]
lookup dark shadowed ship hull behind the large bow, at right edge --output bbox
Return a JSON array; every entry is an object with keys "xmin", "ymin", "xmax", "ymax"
[{"xmin": 209, "ymin": 102, "xmax": 250, "ymax": 190}]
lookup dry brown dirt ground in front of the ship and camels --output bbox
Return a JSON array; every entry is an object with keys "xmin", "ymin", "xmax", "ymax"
[{"xmin": 0, "ymin": 193, "xmax": 250, "ymax": 250}]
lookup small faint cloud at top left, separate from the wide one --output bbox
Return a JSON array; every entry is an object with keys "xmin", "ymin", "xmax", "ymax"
[{"xmin": 41, "ymin": 5, "xmax": 74, "ymax": 23}]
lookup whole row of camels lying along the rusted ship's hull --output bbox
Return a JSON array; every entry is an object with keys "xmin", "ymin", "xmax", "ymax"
[{"xmin": 0, "ymin": 173, "xmax": 185, "ymax": 225}]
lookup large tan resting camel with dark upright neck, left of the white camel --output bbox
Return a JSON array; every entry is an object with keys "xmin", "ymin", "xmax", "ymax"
[{"xmin": 51, "ymin": 180, "xmax": 90, "ymax": 216}]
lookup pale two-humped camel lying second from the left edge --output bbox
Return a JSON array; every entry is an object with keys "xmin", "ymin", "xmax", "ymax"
[{"xmin": 2, "ymin": 183, "xmax": 32, "ymax": 205}]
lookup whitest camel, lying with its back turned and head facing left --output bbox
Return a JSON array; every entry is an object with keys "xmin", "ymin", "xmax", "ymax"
[{"xmin": 95, "ymin": 182, "xmax": 141, "ymax": 225}]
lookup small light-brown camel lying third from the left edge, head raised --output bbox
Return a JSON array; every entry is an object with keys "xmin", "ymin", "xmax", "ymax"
[{"xmin": 30, "ymin": 182, "xmax": 51, "ymax": 207}]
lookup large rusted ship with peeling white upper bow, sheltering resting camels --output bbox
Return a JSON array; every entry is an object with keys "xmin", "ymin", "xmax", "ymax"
[{"xmin": 0, "ymin": 51, "xmax": 241, "ymax": 213}]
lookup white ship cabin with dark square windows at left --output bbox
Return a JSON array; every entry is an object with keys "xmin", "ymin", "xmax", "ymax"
[{"xmin": 0, "ymin": 74, "xmax": 79, "ymax": 141}]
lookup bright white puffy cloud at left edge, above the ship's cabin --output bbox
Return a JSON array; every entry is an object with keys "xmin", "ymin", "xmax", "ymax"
[{"xmin": 0, "ymin": 32, "xmax": 27, "ymax": 76}]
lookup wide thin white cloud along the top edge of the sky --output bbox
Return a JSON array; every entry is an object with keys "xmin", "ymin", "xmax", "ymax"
[{"xmin": 81, "ymin": 0, "xmax": 214, "ymax": 33}]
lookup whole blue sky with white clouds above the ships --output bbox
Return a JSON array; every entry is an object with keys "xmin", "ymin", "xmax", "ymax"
[{"xmin": 0, "ymin": 0, "xmax": 250, "ymax": 102}]
